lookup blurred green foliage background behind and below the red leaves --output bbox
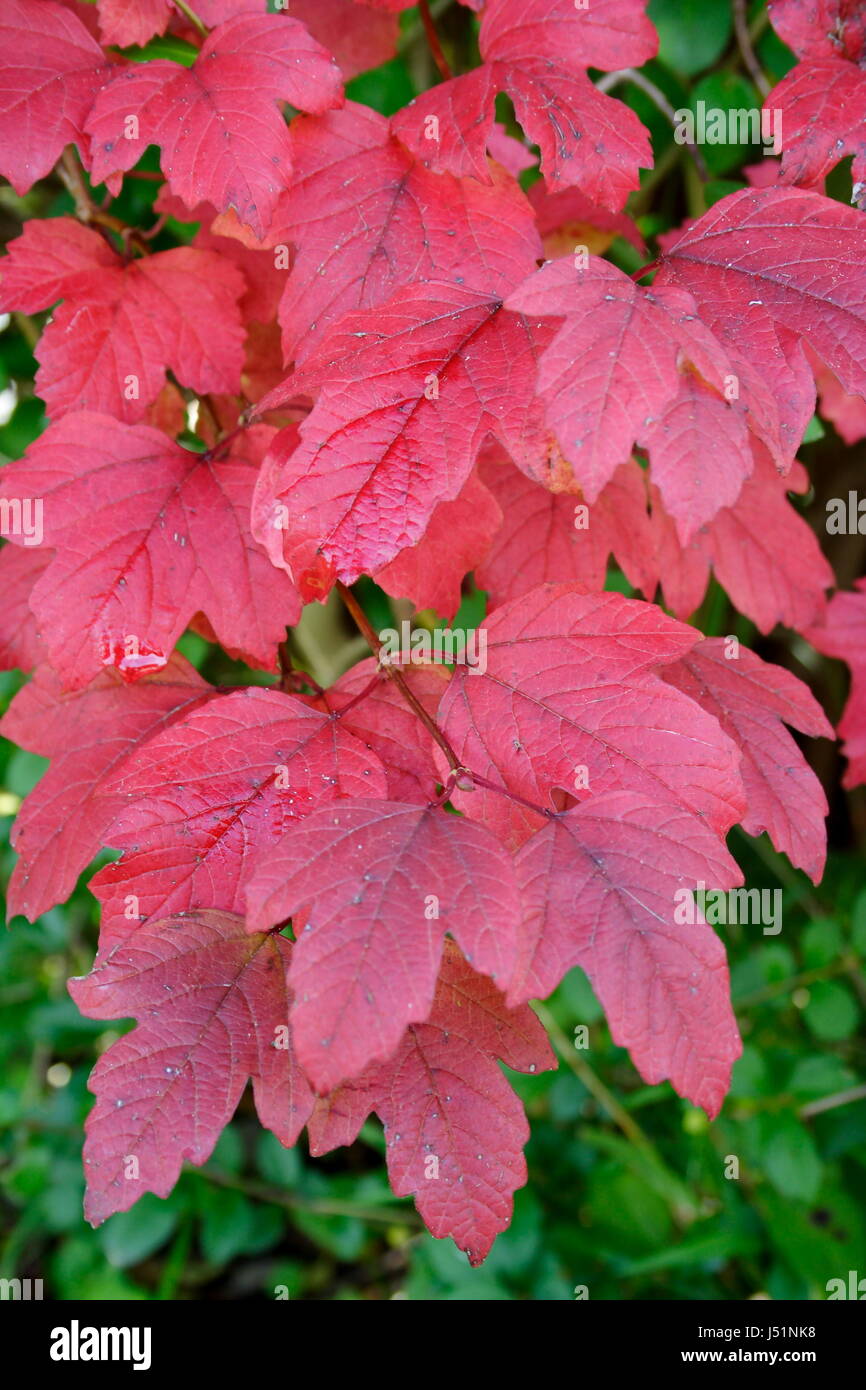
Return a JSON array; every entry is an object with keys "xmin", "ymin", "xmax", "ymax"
[{"xmin": 0, "ymin": 0, "xmax": 866, "ymax": 1301}]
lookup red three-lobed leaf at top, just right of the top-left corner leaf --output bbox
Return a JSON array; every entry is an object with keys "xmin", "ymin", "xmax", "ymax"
[{"xmin": 88, "ymin": 14, "xmax": 342, "ymax": 236}]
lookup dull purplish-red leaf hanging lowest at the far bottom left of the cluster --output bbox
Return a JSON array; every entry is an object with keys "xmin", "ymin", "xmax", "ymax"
[{"xmin": 70, "ymin": 912, "xmax": 313, "ymax": 1226}]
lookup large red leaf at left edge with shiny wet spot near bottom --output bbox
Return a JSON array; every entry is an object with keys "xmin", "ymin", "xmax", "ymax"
[{"xmin": 0, "ymin": 411, "xmax": 300, "ymax": 689}]
